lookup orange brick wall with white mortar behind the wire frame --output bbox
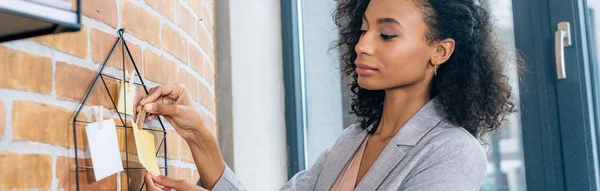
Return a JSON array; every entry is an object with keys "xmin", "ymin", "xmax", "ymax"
[{"xmin": 0, "ymin": 0, "xmax": 216, "ymax": 190}]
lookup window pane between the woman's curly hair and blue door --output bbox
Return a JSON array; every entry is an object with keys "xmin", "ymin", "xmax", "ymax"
[{"xmin": 481, "ymin": 0, "xmax": 526, "ymax": 191}]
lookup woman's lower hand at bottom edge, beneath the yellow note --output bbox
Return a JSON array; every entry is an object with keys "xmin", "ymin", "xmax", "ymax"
[{"xmin": 145, "ymin": 173, "xmax": 208, "ymax": 191}]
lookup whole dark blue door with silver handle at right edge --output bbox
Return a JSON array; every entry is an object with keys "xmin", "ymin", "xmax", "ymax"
[{"xmin": 513, "ymin": 0, "xmax": 600, "ymax": 190}]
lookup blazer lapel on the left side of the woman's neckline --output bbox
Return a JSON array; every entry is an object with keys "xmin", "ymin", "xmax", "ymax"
[{"xmin": 315, "ymin": 130, "xmax": 367, "ymax": 190}]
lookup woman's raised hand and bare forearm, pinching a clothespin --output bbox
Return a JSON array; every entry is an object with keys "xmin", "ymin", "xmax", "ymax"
[{"xmin": 135, "ymin": 84, "xmax": 225, "ymax": 189}]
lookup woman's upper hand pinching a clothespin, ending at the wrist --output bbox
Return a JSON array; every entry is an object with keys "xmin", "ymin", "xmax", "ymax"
[{"xmin": 136, "ymin": 84, "xmax": 208, "ymax": 140}]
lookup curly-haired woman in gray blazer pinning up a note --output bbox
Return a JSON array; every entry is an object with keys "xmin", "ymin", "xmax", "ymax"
[{"xmin": 138, "ymin": 0, "xmax": 514, "ymax": 191}]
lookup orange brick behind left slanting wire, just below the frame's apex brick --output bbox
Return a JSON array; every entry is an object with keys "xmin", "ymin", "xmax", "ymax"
[{"xmin": 55, "ymin": 62, "xmax": 118, "ymax": 110}]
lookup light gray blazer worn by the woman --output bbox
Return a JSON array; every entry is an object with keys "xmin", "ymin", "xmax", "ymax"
[{"xmin": 206, "ymin": 99, "xmax": 487, "ymax": 191}]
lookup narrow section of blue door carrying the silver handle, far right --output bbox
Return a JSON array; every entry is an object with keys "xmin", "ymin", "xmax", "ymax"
[{"xmin": 549, "ymin": 0, "xmax": 600, "ymax": 190}]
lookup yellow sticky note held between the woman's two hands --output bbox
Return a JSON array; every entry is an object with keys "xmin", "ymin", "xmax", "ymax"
[{"xmin": 132, "ymin": 122, "xmax": 160, "ymax": 174}]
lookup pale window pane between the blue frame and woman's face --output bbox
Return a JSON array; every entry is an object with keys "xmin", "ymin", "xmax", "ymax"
[{"xmin": 300, "ymin": 0, "xmax": 344, "ymax": 167}]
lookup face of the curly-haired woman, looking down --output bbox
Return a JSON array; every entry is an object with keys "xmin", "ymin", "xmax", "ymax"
[{"xmin": 355, "ymin": 0, "xmax": 441, "ymax": 90}]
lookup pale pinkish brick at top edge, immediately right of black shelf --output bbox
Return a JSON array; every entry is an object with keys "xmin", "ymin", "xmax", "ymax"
[{"xmin": 81, "ymin": 0, "xmax": 119, "ymax": 28}]
